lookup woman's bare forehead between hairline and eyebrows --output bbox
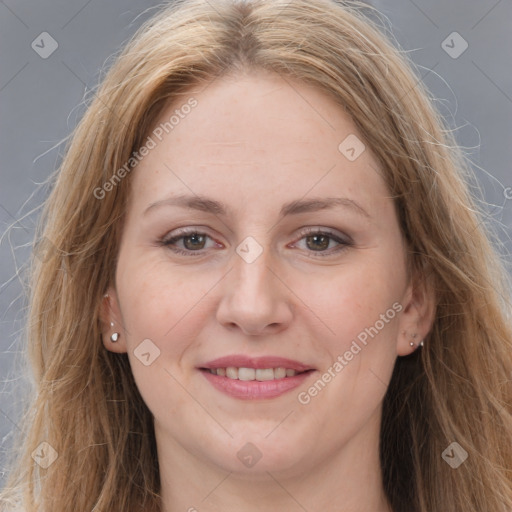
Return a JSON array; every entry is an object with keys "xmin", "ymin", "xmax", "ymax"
[{"xmin": 127, "ymin": 67, "xmax": 387, "ymax": 218}]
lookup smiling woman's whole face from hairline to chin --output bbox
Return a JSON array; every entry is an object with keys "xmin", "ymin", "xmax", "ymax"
[{"xmin": 105, "ymin": 72, "xmax": 426, "ymax": 475}]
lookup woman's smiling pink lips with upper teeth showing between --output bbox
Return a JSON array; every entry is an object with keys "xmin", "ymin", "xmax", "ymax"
[{"xmin": 199, "ymin": 355, "xmax": 315, "ymax": 400}]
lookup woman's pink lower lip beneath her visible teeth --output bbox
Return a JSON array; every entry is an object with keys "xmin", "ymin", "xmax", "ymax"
[{"xmin": 201, "ymin": 370, "xmax": 313, "ymax": 400}]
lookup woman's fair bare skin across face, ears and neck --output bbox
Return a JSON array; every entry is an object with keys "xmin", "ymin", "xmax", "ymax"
[{"xmin": 102, "ymin": 71, "xmax": 432, "ymax": 512}]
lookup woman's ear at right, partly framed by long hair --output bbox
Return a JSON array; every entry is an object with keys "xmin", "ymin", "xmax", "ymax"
[{"xmin": 396, "ymin": 276, "xmax": 436, "ymax": 356}]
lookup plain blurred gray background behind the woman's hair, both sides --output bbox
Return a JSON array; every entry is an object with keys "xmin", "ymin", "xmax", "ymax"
[{"xmin": 0, "ymin": 0, "xmax": 512, "ymax": 488}]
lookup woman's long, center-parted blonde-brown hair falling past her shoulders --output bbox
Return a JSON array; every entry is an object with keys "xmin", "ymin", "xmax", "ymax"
[{"xmin": 2, "ymin": 0, "xmax": 512, "ymax": 512}]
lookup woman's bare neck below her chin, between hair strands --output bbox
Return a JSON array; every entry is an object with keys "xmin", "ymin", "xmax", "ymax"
[{"xmin": 155, "ymin": 413, "xmax": 392, "ymax": 512}]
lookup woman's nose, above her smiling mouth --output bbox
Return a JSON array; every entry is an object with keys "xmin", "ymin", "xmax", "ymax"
[{"xmin": 217, "ymin": 244, "xmax": 293, "ymax": 335}]
